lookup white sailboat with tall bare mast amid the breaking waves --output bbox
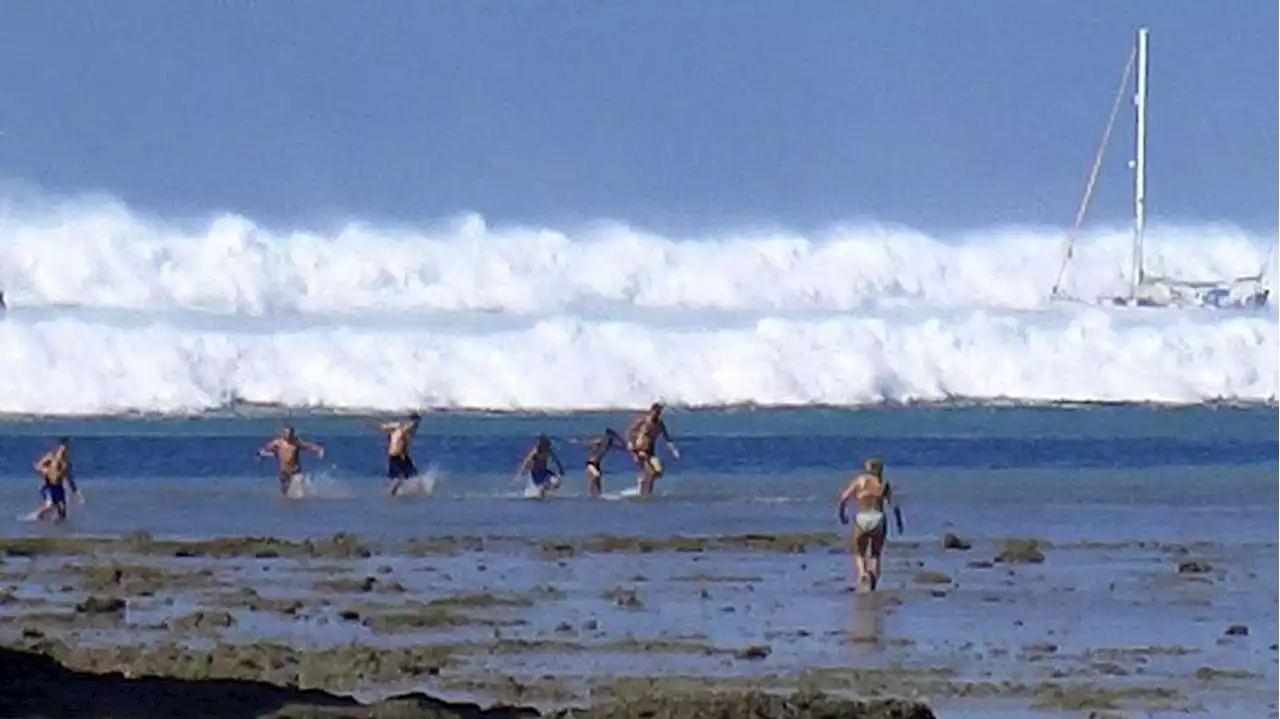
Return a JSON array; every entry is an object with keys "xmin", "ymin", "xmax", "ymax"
[{"xmin": 1050, "ymin": 28, "xmax": 1271, "ymax": 310}]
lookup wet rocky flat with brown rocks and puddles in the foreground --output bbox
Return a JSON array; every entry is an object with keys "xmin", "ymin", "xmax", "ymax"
[{"xmin": 0, "ymin": 533, "xmax": 1280, "ymax": 716}]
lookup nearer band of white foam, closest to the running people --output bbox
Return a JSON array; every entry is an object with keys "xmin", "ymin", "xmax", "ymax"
[{"xmin": 0, "ymin": 304, "xmax": 1280, "ymax": 413}]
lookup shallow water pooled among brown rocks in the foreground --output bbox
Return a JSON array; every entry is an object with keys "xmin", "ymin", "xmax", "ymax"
[{"xmin": 0, "ymin": 529, "xmax": 1280, "ymax": 716}]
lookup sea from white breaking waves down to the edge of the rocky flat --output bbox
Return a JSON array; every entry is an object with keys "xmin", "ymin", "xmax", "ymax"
[{"xmin": 0, "ymin": 200, "xmax": 1280, "ymax": 547}]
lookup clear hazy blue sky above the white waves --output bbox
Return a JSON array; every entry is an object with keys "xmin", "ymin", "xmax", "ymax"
[{"xmin": 0, "ymin": 0, "xmax": 1280, "ymax": 229}]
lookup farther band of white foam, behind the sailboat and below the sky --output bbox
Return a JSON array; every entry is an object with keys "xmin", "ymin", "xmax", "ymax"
[{"xmin": 0, "ymin": 194, "xmax": 1272, "ymax": 315}]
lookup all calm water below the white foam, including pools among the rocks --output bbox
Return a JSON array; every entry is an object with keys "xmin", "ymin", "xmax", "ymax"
[{"xmin": 0, "ymin": 408, "xmax": 1280, "ymax": 716}]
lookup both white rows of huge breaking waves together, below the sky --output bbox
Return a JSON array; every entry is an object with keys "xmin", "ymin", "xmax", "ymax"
[{"xmin": 0, "ymin": 195, "xmax": 1280, "ymax": 415}]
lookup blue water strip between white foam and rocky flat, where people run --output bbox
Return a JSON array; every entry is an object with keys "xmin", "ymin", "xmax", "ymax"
[{"xmin": 0, "ymin": 407, "xmax": 1280, "ymax": 542}]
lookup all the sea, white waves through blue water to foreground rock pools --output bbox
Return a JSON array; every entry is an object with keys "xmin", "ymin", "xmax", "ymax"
[{"xmin": 0, "ymin": 201, "xmax": 1280, "ymax": 716}]
